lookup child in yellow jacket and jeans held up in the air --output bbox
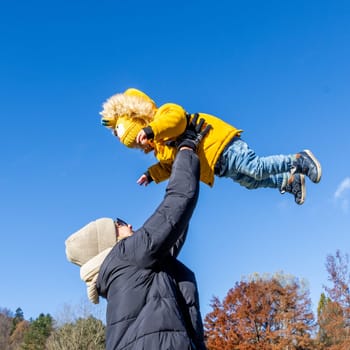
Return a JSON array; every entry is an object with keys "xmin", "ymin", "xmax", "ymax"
[{"xmin": 100, "ymin": 88, "xmax": 322, "ymax": 205}]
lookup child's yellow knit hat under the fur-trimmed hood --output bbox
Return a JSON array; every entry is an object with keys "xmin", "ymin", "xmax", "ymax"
[{"xmin": 115, "ymin": 116, "xmax": 146, "ymax": 148}]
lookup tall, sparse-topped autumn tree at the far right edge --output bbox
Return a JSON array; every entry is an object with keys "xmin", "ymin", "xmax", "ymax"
[{"xmin": 318, "ymin": 250, "xmax": 350, "ymax": 350}]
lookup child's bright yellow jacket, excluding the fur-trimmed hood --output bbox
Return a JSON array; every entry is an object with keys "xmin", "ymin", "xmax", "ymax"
[{"xmin": 148, "ymin": 103, "xmax": 242, "ymax": 186}]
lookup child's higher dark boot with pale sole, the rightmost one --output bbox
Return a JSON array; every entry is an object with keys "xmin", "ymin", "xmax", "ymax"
[{"xmin": 291, "ymin": 149, "xmax": 322, "ymax": 183}]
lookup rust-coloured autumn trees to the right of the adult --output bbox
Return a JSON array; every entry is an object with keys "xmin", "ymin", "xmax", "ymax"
[{"xmin": 204, "ymin": 251, "xmax": 350, "ymax": 350}]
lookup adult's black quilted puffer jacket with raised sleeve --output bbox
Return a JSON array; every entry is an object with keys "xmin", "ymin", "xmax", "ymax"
[{"xmin": 97, "ymin": 150, "xmax": 205, "ymax": 350}]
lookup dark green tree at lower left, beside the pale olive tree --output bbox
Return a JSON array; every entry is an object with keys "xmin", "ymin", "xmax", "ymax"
[{"xmin": 22, "ymin": 314, "xmax": 53, "ymax": 350}]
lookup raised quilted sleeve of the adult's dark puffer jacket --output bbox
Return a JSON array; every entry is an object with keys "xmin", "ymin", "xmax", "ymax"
[{"xmin": 119, "ymin": 150, "xmax": 200, "ymax": 268}]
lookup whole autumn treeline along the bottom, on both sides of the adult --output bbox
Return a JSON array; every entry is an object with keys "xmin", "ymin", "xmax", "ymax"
[{"xmin": 0, "ymin": 251, "xmax": 350, "ymax": 350}]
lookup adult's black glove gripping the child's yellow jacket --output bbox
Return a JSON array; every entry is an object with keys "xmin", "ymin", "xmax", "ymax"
[{"xmin": 175, "ymin": 113, "xmax": 211, "ymax": 152}]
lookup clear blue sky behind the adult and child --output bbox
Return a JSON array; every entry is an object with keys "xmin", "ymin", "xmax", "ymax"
[{"xmin": 0, "ymin": 0, "xmax": 350, "ymax": 318}]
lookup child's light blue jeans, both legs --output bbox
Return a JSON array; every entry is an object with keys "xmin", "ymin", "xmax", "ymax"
[{"xmin": 216, "ymin": 137, "xmax": 295, "ymax": 190}]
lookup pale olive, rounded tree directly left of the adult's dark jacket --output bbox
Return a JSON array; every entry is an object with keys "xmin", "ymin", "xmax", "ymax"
[{"xmin": 46, "ymin": 316, "xmax": 105, "ymax": 350}]
